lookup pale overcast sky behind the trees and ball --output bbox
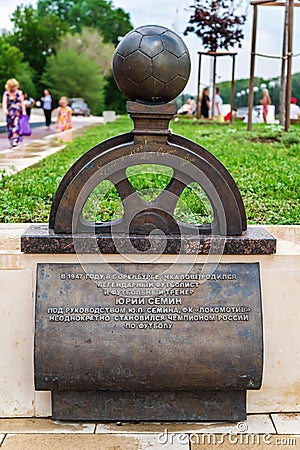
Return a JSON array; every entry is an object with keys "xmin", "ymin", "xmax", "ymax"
[{"xmin": 0, "ymin": 0, "xmax": 300, "ymax": 94}]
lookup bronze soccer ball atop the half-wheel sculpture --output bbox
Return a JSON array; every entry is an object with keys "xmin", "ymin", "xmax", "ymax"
[{"xmin": 113, "ymin": 25, "xmax": 191, "ymax": 104}]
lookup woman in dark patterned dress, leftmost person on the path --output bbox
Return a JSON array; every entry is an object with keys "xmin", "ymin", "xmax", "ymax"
[{"xmin": 2, "ymin": 78, "xmax": 26, "ymax": 147}]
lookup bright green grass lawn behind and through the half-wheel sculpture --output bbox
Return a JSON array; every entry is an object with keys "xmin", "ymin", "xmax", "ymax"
[{"xmin": 0, "ymin": 117, "xmax": 300, "ymax": 224}]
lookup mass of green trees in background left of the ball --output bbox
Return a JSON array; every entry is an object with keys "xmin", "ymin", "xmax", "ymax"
[{"xmin": 0, "ymin": 0, "xmax": 132, "ymax": 113}]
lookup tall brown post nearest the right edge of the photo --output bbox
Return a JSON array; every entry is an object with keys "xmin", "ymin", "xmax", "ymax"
[{"xmin": 284, "ymin": 0, "xmax": 294, "ymax": 131}]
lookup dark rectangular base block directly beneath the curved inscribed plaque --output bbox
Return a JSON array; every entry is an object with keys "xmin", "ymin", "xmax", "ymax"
[{"xmin": 52, "ymin": 391, "xmax": 246, "ymax": 422}]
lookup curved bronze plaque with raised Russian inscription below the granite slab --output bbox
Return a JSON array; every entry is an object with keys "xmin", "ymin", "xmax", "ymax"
[{"xmin": 35, "ymin": 263, "xmax": 263, "ymax": 420}]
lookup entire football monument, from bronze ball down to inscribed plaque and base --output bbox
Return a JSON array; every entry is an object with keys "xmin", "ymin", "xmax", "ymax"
[{"xmin": 22, "ymin": 25, "xmax": 276, "ymax": 421}]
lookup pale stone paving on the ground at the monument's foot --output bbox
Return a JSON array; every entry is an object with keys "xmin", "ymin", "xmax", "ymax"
[{"xmin": 0, "ymin": 413, "xmax": 300, "ymax": 450}]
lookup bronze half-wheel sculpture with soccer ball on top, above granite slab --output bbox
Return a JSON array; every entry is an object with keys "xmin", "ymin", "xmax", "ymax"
[{"xmin": 49, "ymin": 26, "xmax": 247, "ymax": 236}]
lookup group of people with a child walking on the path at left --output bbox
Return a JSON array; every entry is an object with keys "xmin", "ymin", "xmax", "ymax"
[{"xmin": 2, "ymin": 78, "xmax": 72, "ymax": 147}]
